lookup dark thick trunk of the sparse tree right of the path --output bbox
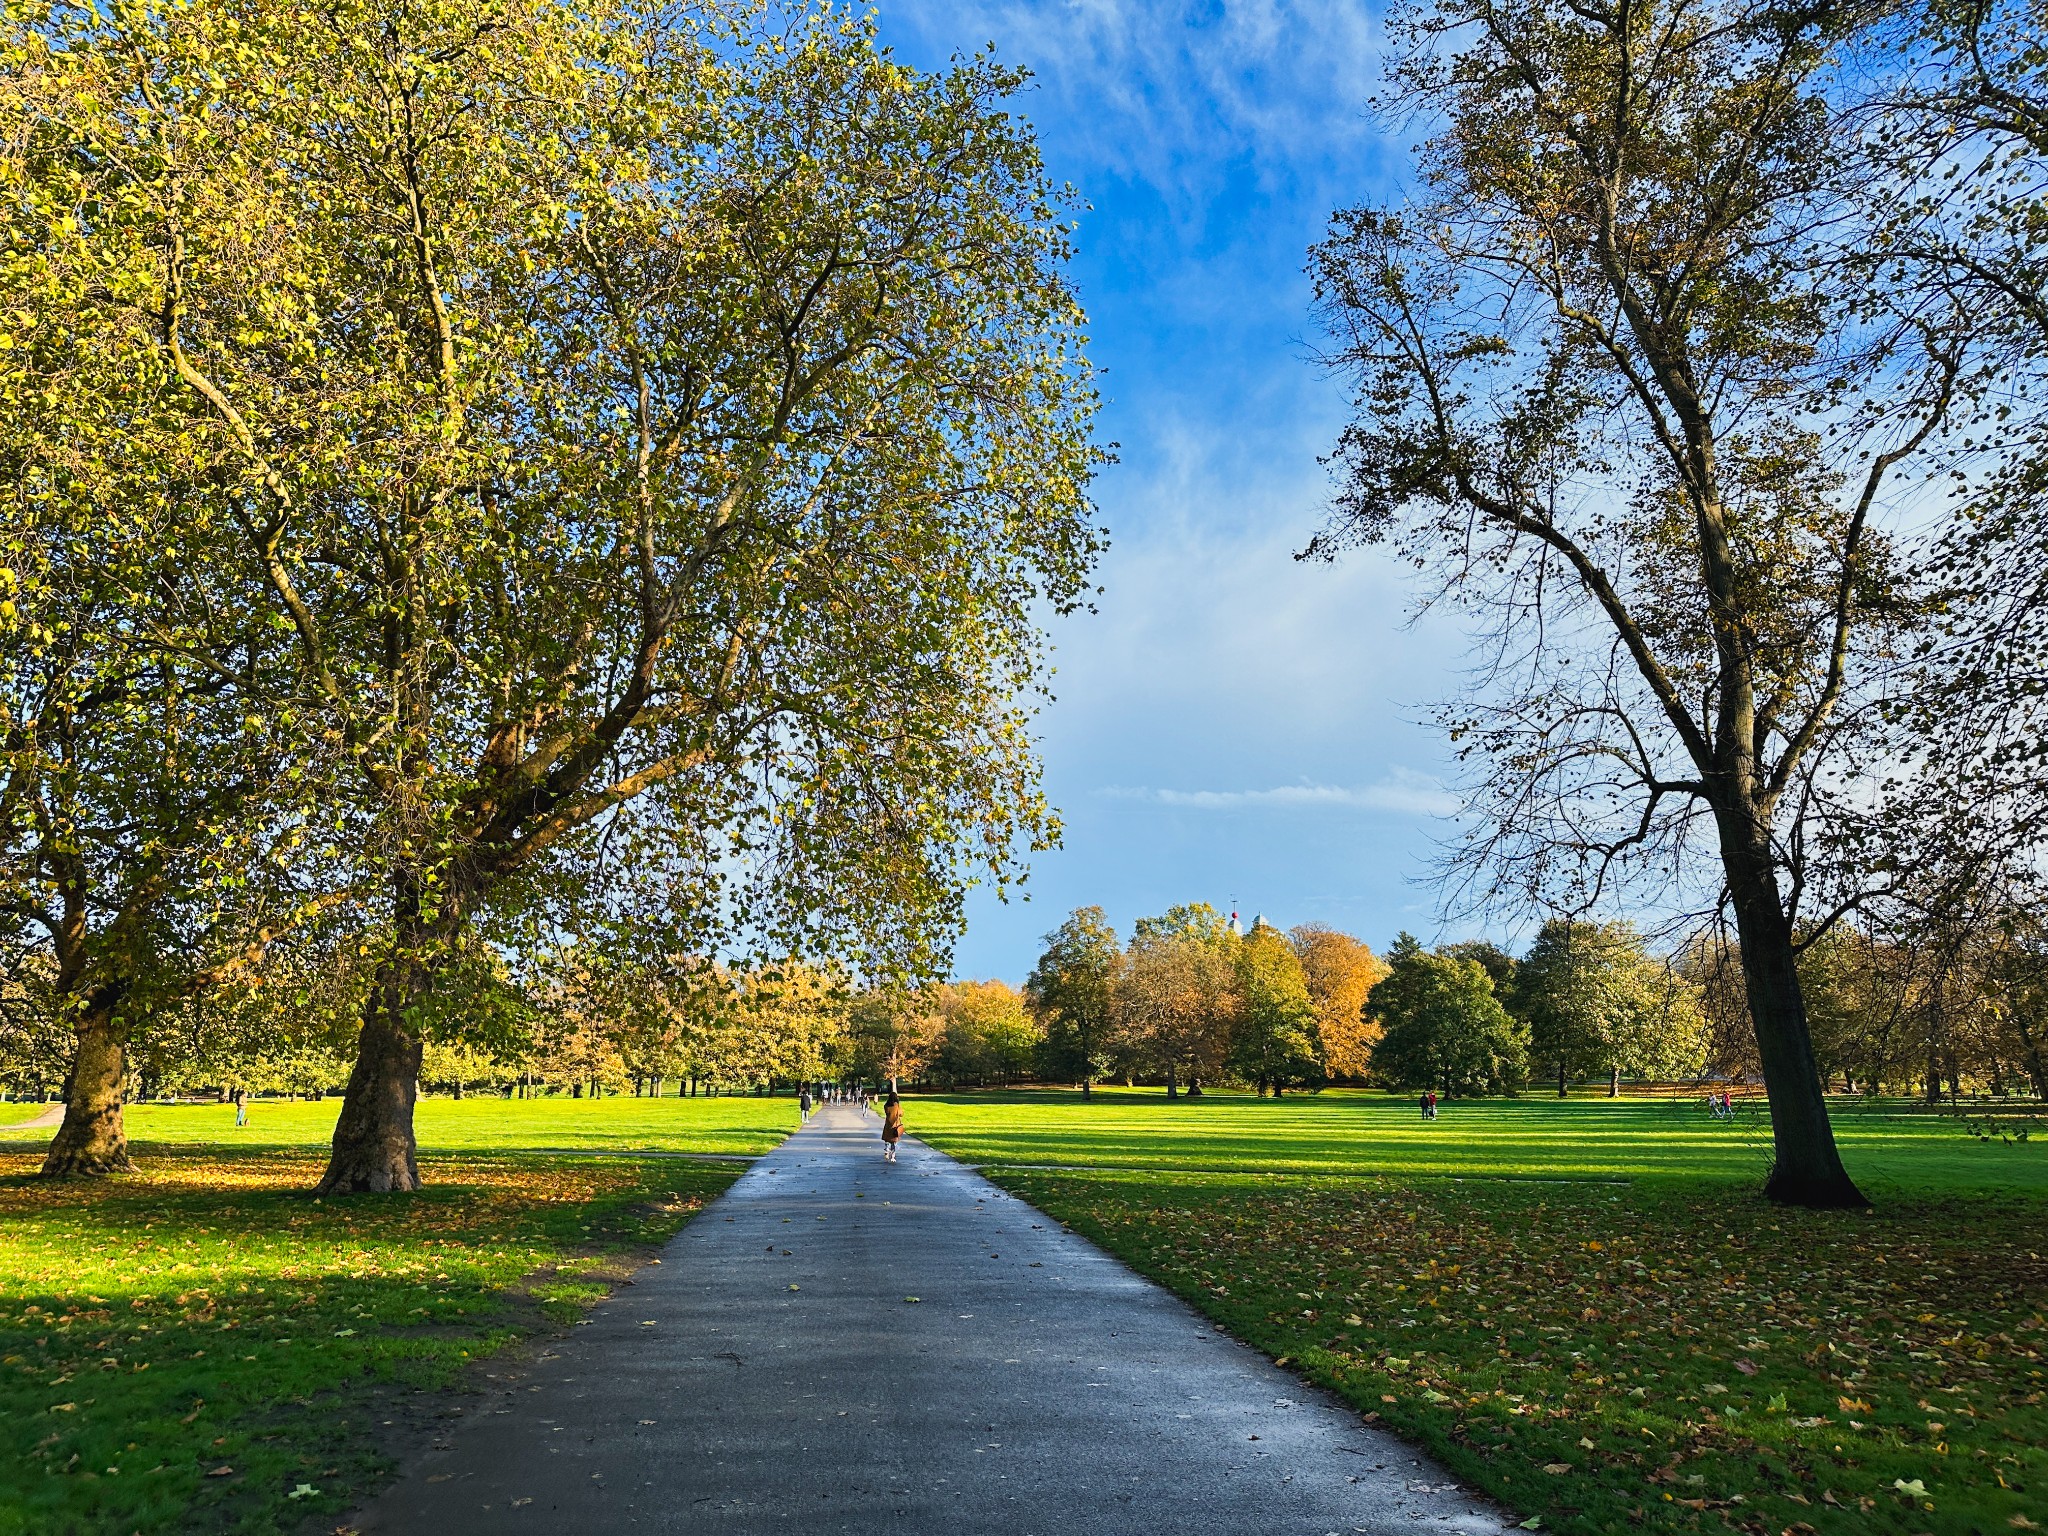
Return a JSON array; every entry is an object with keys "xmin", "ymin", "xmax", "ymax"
[{"xmin": 1722, "ymin": 838, "xmax": 1870, "ymax": 1208}]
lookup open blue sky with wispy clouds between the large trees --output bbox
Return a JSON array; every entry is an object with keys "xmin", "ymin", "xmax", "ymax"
[{"xmin": 879, "ymin": 0, "xmax": 1462, "ymax": 981}]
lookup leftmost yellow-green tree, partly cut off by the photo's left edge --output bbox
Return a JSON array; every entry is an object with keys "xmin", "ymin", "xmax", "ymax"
[{"xmin": 0, "ymin": 54, "xmax": 313, "ymax": 1176}]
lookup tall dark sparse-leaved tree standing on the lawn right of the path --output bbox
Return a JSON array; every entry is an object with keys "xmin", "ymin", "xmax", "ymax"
[{"xmin": 1313, "ymin": 0, "xmax": 1956, "ymax": 1206}]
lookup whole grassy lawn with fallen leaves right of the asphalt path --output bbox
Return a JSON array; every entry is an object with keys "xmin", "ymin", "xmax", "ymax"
[{"xmin": 909, "ymin": 1094, "xmax": 2048, "ymax": 1536}]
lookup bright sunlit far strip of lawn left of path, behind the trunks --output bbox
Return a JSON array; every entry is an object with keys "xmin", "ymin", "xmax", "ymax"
[{"xmin": 0, "ymin": 1098, "xmax": 797, "ymax": 1155}]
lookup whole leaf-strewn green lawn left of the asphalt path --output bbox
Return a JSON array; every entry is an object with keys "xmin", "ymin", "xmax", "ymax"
[{"xmin": 0, "ymin": 1100, "xmax": 795, "ymax": 1536}]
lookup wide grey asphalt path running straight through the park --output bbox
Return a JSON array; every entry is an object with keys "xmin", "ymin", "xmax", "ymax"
[{"xmin": 350, "ymin": 1106, "xmax": 1507, "ymax": 1536}]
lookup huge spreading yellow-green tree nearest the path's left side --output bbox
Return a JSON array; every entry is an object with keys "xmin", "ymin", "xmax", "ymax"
[{"xmin": 32, "ymin": 0, "xmax": 1098, "ymax": 1192}]
